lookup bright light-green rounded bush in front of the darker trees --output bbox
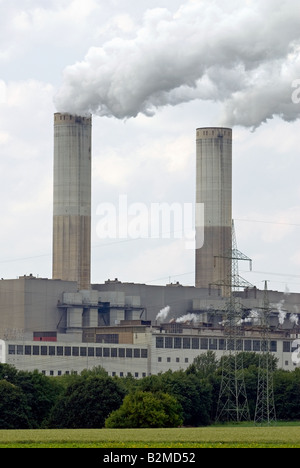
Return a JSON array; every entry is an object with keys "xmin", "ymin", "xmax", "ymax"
[{"xmin": 105, "ymin": 391, "xmax": 182, "ymax": 428}]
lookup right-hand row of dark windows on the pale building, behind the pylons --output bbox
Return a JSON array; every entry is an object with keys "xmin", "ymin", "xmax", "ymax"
[{"xmin": 156, "ymin": 336, "xmax": 284, "ymax": 353}]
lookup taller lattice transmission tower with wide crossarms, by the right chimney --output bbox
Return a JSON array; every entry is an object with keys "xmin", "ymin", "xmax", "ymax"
[{"xmin": 217, "ymin": 223, "xmax": 251, "ymax": 422}]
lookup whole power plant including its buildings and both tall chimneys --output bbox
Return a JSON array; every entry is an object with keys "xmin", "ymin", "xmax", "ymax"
[{"xmin": 0, "ymin": 113, "xmax": 300, "ymax": 378}]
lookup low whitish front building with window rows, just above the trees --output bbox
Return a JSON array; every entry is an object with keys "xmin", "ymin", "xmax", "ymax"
[{"xmin": 0, "ymin": 321, "xmax": 298, "ymax": 378}]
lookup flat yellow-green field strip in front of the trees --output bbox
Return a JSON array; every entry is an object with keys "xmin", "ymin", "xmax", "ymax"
[{"xmin": 0, "ymin": 425, "xmax": 300, "ymax": 448}]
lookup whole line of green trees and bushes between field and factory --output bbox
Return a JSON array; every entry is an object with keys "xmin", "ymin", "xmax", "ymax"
[{"xmin": 0, "ymin": 351, "xmax": 300, "ymax": 429}]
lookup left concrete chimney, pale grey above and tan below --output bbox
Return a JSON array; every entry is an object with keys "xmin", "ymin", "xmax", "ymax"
[{"xmin": 53, "ymin": 113, "xmax": 92, "ymax": 290}]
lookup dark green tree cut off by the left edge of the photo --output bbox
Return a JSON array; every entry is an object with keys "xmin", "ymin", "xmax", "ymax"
[{"xmin": 0, "ymin": 380, "xmax": 30, "ymax": 429}]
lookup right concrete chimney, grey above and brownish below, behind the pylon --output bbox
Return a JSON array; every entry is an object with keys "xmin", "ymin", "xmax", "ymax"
[{"xmin": 195, "ymin": 128, "xmax": 232, "ymax": 295}]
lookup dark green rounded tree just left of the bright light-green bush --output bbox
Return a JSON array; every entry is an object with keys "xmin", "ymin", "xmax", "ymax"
[{"xmin": 47, "ymin": 373, "xmax": 124, "ymax": 429}]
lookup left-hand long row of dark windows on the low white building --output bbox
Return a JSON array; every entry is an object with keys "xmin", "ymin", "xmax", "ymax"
[{"xmin": 8, "ymin": 345, "xmax": 148, "ymax": 359}]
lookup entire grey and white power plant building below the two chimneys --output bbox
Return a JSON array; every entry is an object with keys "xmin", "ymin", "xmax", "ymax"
[{"xmin": 0, "ymin": 276, "xmax": 300, "ymax": 378}]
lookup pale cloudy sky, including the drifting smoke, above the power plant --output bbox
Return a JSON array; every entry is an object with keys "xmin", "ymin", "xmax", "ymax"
[{"xmin": 0, "ymin": 0, "xmax": 300, "ymax": 292}]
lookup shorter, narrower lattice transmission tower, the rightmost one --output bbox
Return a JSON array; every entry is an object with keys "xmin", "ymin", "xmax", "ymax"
[{"xmin": 254, "ymin": 281, "xmax": 276, "ymax": 425}]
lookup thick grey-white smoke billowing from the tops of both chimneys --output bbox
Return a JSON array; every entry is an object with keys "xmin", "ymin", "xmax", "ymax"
[{"xmin": 55, "ymin": 0, "xmax": 300, "ymax": 128}]
